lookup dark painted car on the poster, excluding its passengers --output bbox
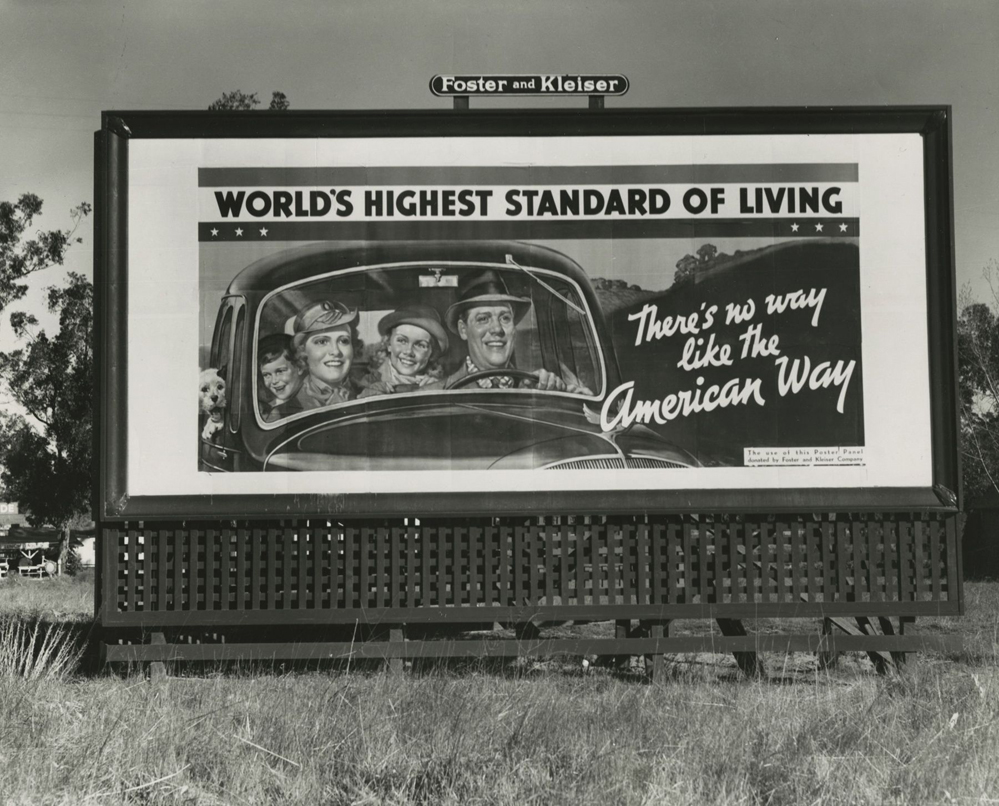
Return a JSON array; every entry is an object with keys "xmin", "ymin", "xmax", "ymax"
[{"xmin": 199, "ymin": 241, "xmax": 698, "ymax": 472}]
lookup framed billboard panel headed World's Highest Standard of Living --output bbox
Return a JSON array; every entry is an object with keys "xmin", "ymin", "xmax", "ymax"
[{"xmin": 101, "ymin": 112, "xmax": 958, "ymax": 517}]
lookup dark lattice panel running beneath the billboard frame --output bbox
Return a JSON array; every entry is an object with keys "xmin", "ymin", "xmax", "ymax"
[{"xmin": 102, "ymin": 515, "xmax": 960, "ymax": 624}]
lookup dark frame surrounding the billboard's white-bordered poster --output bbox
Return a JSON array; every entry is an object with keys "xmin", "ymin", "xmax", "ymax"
[{"xmin": 95, "ymin": 107, "xmax": 960, "ymax": 523}]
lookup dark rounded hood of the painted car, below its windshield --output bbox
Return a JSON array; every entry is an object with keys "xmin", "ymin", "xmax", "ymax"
[{"xmin": 265, "ymin": 395, "xmax": 696, "ymax": 471}]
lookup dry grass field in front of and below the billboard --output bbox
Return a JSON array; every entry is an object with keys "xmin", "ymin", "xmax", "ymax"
[{"xmin": 0, "ymin": 577, "xmax": 999, "ymax": 806}]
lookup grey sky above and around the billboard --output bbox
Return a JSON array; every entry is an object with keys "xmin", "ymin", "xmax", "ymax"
[{"xmin": 0, "ymin": 0, "xmax": 999, "ymax": 340}]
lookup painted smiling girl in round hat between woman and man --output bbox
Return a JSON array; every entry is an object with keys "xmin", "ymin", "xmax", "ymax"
[{"xmin": 359, "ymin": 305, "xmax": 448, "ymax": 397}]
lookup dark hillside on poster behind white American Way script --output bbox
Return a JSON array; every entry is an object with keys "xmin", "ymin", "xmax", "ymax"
[{"xmin": 605, "ymin": 241, "xmax": 864, "ymax": 466}]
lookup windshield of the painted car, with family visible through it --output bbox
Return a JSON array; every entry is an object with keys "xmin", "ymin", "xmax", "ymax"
[{"xmin": 254, "ymin": 262, "xmax": 605, "ymax": 428}]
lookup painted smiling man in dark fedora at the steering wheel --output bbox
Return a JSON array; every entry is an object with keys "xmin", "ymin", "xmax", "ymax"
[{"xmin": 444, "ymin": 269, "xmax": 582, "ymax": 392}]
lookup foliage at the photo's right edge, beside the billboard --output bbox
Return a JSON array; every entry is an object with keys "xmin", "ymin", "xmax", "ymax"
[{"xmin": 957, "ymin": 261, "xmax": 999, "ymax": 499}]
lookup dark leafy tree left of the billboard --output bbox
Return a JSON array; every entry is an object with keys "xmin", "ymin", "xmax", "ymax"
[{"xmin": 0, "ymin": 194, "xmax": 93, "ymax": 540}]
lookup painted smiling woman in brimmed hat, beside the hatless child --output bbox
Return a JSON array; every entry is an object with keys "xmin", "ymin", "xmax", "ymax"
[{"xmin": 292, "ymin": 300, "xmax": 360, "ymax": 409}]
